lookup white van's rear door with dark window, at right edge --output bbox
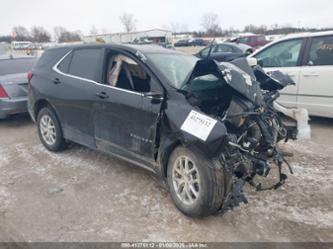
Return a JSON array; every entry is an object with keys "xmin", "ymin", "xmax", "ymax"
[{"xmin": 298, "ymin": 35, "xmax": 333, "ymax": 117}]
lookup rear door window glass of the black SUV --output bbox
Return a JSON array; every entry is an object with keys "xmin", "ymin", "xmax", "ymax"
[{"xmin": 68, "ymin": 49, "xmax": 102, "ymax": 80}]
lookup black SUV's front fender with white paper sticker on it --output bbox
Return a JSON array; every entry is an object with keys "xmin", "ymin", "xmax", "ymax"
[{"xmin": 158, "ymin": 93, "xmax": 228, "ymax": 175}]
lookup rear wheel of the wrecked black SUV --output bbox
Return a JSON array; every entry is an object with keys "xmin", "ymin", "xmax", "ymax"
[{"xmin": 37, "ymin": 107, "xmax": 66, "ymax": 151}]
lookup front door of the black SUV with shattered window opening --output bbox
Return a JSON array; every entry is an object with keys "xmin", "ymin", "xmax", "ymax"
[{"xmin": 94, "ymin": 51, "xmax": 163, "ymax": 167}]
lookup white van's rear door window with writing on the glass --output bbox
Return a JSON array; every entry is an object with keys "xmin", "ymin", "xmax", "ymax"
[{"xmin": 307, "ymin": 36, "xmax": 333, "ymax": 66}]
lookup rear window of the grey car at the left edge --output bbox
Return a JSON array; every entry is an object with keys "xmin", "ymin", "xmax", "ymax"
[{"xmin": 0, "ymin": 58, "xmax": 37, "ymax": 75}]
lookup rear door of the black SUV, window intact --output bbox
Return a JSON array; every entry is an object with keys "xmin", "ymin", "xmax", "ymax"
[{"xmin": 52, "ymin": 48, "xmax": 102, "ymax": 148}]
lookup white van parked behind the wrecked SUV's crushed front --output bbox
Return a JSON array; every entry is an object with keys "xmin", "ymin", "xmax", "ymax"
[{"xmin": 250, "ymin": 31, "xmax": 333, "ymax": 118}]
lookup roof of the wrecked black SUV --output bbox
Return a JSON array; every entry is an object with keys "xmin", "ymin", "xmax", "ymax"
[{"xmin": 49, "ymin": 43, "xmax": 183, "ymax": 54}]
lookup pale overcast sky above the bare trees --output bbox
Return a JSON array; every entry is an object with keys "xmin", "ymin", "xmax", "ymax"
[{"xmin": 0, "ymin": 0, "xmax": 333, "ymax": 34}]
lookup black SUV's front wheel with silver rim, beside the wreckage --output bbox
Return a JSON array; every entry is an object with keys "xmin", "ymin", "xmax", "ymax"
[{"xmin": 167, "ymin": 146, "xmax": 225, "ymax": 217}]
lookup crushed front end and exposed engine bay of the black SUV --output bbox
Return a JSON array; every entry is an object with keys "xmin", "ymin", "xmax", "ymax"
[{"xmin": 180, "ymin": 59, "xmax": 310, "ymax": 212}]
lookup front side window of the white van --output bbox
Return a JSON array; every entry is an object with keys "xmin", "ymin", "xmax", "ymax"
[{"xmin": 255, "ymin": 39, "xmax": 303, "ymax": 67}]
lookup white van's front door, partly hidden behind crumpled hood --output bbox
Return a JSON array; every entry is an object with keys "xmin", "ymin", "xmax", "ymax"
[{"xmin": 253, "ymin": 38, "xmax": 305, "ymax": 107}]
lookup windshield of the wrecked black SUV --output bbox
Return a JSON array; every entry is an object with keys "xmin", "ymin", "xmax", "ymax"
[{"xmin": 147, "ymin": 54, "xmax": 199, "ymax": 89}]
